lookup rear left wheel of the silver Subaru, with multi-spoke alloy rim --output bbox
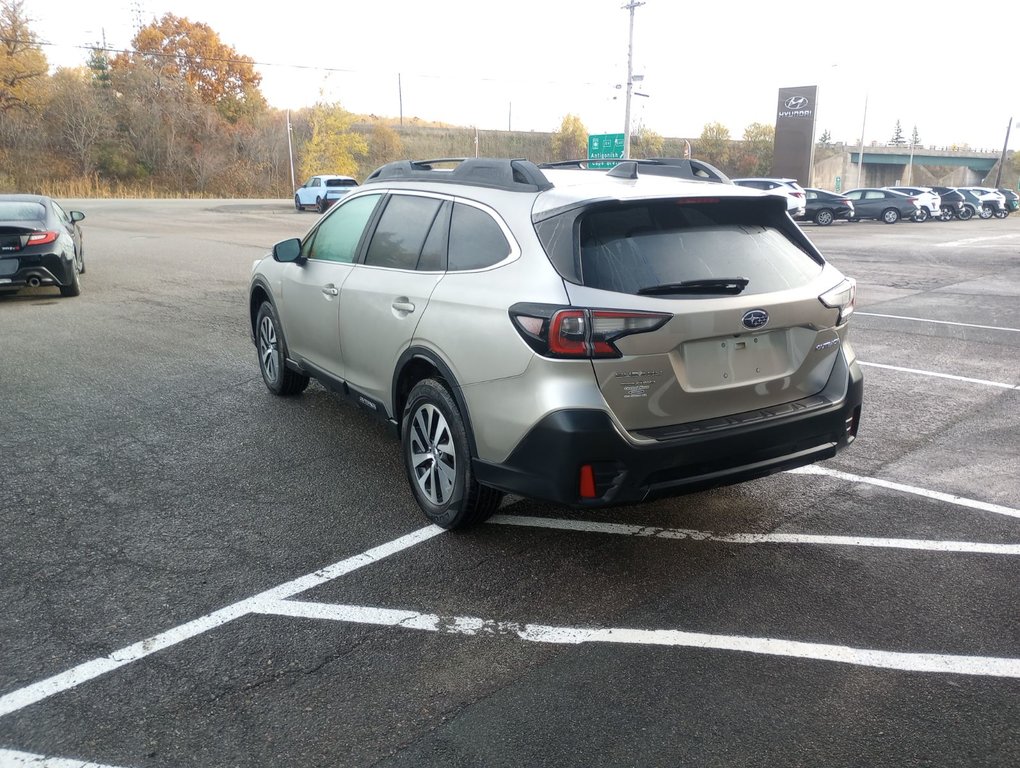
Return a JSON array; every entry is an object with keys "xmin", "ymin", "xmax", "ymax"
[{"xmin": 401, "ymin": 378, "xmax": 503, "ymax": 529}]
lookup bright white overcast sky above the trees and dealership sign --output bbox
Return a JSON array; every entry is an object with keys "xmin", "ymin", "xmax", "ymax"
[{"xmin": 24, "ymin": 0, "xmax": 1020, "ymax": 151}]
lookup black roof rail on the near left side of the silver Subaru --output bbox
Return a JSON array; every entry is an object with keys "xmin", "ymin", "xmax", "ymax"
[{"xmin": 365, "ymin": 157, "xmax": 553, "ymax": 192}]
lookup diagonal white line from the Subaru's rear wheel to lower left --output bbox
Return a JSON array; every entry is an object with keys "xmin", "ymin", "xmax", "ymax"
[{"xmin": 0, "ymin": 525, "xmax": 443, "ymax": 717}]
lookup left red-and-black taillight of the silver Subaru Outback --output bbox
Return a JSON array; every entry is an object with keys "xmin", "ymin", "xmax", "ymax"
[{"xmin": 510, "ymin": 304, "xmax": 672, "ymax": 359}]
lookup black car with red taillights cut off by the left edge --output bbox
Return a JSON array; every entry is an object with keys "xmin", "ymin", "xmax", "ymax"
[{"xmin": 0, "ymin": 195, "xmax": 85, "ymax": 296}]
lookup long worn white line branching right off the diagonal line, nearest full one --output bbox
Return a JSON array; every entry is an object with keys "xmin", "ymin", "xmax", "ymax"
[{"xmin": 259, "ymin": 600, "xmax": 1020, "ymax": 677}]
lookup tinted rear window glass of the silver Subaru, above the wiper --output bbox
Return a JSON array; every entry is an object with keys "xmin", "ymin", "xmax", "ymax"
[{"xmin": 537, "ymin": 200, "xmax": 822, "ymax": 295}]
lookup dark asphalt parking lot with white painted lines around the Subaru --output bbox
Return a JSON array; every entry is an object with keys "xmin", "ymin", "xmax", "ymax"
[{"xmin": 0, "ymin": 201, "xmax": 1020, "ymax": 768}]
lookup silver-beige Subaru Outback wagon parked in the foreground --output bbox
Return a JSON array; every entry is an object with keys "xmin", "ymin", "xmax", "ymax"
[{"xmin": 249, "ymin": 158, "xmax": 863, "ymax": 528}]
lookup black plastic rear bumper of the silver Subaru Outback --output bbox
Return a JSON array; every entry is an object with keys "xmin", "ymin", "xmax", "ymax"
[{"xmin": 473, "ymin": 355, "xmax": 864, "ymax": 508}]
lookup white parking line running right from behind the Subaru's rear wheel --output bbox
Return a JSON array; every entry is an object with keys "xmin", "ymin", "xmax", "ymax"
[{"xmin": 489, "ymin": 515, "xmax": 1020, "ymax": 557}]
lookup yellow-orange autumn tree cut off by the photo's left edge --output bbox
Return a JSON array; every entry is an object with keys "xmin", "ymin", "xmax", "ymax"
[{"xmin": 0, "ymin": 0, "xmax": 47, "ymax": 113}]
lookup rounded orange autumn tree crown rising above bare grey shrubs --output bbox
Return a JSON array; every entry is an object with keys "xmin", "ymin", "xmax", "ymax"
[{"xmin": 127, "ymin": 13, "xmax": 265, "ymax": 122}]
